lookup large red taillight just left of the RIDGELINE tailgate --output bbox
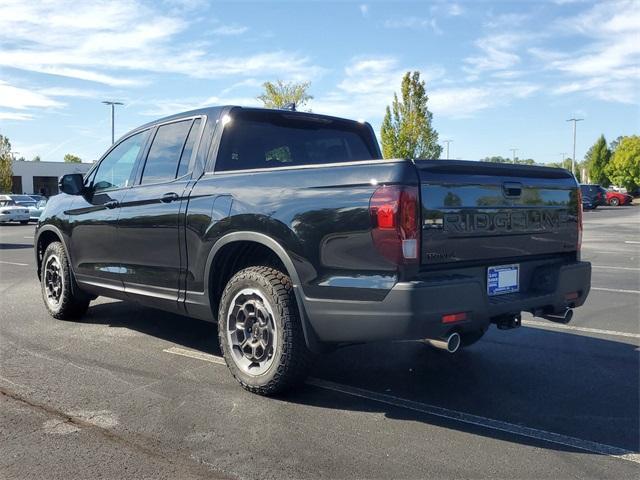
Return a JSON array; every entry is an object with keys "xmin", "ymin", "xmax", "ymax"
[{"xmin": 369, "ymin": 185, "xmax": 420, "ymax": 265}]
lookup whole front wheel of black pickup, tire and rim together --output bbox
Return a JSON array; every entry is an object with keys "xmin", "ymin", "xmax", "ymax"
[{"xmin": 40, "ymin": 242, "xmax": 90, "ymax": 319}]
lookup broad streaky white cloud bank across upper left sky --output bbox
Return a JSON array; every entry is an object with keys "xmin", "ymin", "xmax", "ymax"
[{"xmin": 0, "ymin": 0, "xmax": 324, "ymax": 87}]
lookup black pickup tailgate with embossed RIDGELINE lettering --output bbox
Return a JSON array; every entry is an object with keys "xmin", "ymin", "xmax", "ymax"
[{"xmin": 415, "ymin": 160, "xmax": 581, "ymax": 265}]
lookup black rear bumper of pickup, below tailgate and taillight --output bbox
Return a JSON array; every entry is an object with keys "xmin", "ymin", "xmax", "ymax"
[{"xmin": 303, "ymin": 262, "xmax": 591, "ymax": 343}]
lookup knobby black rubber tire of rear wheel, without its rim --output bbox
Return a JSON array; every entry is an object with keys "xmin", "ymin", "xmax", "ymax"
[{"xmin": 218, "ymin": 266, "xmax": 313, "ymax": 395}]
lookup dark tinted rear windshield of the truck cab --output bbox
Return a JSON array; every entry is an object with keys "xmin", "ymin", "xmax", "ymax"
[{"xmin": 216, "ymin": 111, "xmax": 380, "ymax": 171}]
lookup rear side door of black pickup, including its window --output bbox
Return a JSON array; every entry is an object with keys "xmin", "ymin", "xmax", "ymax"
[{"xmin": 118, "ymin": 118, "xmax": 202, "ymax": 312}]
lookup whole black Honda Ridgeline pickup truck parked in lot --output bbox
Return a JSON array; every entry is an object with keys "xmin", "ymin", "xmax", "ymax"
[{"xmin": 35, "ymin": 106, "xmax": 591, "ymax": 394}]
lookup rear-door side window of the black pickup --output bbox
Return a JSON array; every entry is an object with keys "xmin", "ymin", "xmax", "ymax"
[{"xmin": 140, "ymin": 120, "xmax": 193, "ymax": 184}]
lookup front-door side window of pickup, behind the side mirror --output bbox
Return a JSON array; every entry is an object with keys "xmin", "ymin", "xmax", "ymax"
[{"xmin": 92, "ymin": 130, "xmax": 149, "ymax": 191}]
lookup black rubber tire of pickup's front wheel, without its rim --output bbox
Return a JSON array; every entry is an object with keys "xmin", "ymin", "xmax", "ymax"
[{"xmin": 40, "ymin": 242, "xmax": 91, "ymax": 320}]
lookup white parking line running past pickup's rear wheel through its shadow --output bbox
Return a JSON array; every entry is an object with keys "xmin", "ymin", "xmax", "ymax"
[{"xmin": 163, "ymin": 347, "xmax": 640, "ymax": 463}]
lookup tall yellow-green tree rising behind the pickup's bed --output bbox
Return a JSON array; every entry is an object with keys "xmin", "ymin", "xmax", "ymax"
[{"xmin": 380, "ymin": 72, "xmax": 442, "ymax": 158}]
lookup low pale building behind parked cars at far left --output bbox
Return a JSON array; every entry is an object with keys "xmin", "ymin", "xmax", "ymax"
[{"xmin": 11, "ymin": 161, "xmax": 93, "ymax": 196}]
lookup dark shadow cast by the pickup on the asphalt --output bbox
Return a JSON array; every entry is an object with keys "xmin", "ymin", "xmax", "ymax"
[{"xmin": 85, "ymin": 302, "xmax": 640, "ymax": 454}]
